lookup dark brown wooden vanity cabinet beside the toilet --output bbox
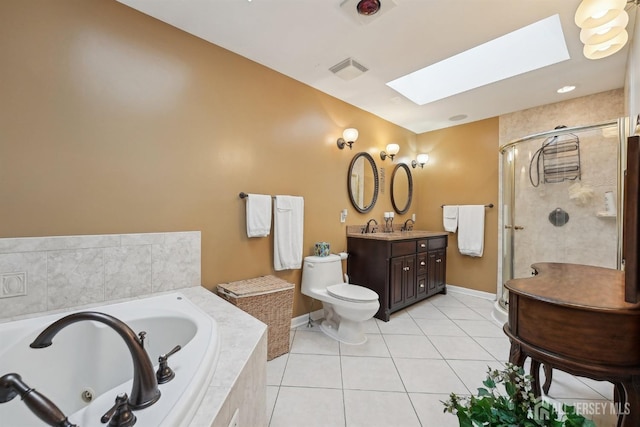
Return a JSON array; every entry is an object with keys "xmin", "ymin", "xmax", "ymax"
[{"xmin": 347, "ymin": 235, "xmax": 447, "ymax": 321}]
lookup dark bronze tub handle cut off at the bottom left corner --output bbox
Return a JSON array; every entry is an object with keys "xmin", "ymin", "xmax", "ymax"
[{"xmin": 0, "ymin": 373, "xmax": 77, "ymax": 427}]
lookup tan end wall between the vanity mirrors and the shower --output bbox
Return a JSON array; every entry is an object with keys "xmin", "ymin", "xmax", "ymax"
[{"xmin": 414, "ymin": 118, "xmax": 499, "ymax": 293}]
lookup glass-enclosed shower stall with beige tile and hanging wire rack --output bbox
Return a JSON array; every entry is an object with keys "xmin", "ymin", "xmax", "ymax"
[{"xmin": 494, "ymin": 119, "xmax": 626, "ymax": 321}]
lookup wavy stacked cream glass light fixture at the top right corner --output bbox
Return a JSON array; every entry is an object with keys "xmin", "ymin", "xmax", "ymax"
[{"xmin": 575, "ymin": 0, "xmax": 638, "ymax": 59}]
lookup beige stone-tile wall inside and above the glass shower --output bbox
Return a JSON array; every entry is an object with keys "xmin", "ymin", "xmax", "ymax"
[{"xmin": 498, "ymin": 89, "xmax": 624, "ymax": 280}]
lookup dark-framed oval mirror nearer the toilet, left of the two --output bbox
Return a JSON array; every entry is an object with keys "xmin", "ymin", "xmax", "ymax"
[{"xmin": 347, "ymin": 152, "xmax": 378, "ymax": 213}]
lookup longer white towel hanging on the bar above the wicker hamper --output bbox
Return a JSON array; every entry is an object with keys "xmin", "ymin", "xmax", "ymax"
[{"xmin": 273, "ymin": 196, "xmax": 304, "ymax": 271}]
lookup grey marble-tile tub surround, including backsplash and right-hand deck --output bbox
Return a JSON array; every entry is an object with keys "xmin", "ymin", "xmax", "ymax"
[{"xmin": 0, "ymin": 232, "xmax": 267, "ymax": 427}]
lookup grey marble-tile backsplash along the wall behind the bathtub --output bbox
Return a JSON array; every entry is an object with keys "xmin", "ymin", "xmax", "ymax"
[{"xmin": 0, "ymin": 231, "xmax": 201, "ymax": 319}]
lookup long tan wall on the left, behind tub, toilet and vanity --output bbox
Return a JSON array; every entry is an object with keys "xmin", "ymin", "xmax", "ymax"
[{"xmin": 0, "ymin": 0, "xmax": 416, "ymax": 316}]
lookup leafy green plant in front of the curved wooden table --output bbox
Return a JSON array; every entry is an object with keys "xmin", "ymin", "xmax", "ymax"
[{"xmin": 442, "ymin": 363, "xmax": 596, "ymax": 427}]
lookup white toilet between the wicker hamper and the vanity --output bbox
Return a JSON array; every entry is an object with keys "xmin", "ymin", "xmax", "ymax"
[{"xmin": 301, "ymin": 254, "xmax": 380, "ymax": 344}]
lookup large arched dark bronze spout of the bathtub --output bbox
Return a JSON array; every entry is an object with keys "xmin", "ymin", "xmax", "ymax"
[{"xmin": 30, "ymin": 311, "xmax": 160, "ymax": 409}]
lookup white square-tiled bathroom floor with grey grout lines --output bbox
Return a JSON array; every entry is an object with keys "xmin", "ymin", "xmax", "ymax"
[{"xmin": 267, "ymin": 291, "xmax": 615, "ymax": 427}]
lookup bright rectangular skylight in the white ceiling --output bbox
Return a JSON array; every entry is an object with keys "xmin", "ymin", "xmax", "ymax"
[{"xmin": 387, "ymin": 15, "xmax": 569, "ymax": 105}]
